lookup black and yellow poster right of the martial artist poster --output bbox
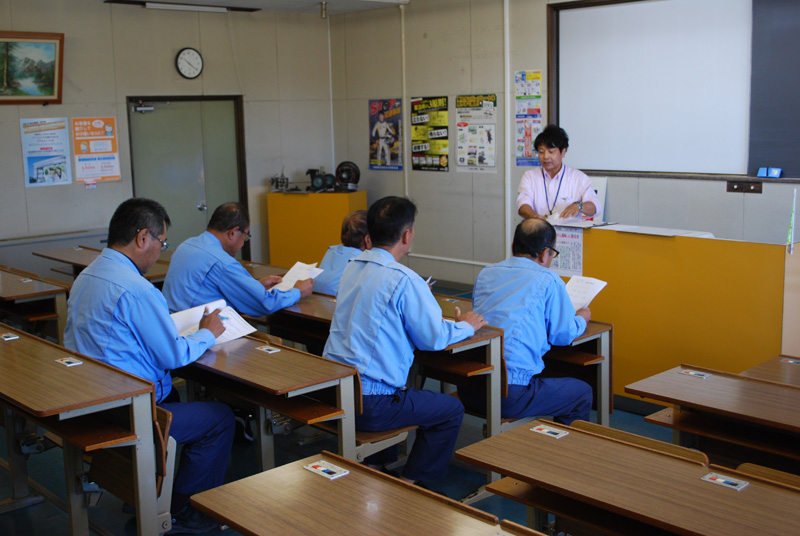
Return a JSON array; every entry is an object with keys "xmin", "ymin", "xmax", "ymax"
[{"xmin": 411, "ymin": 97, "xmax": 450, "ymax": 171}]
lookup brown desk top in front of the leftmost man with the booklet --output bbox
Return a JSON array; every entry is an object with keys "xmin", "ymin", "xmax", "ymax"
[{"xmin": 189, "ymin": 337, "xmax": 356, "ymax": 395}]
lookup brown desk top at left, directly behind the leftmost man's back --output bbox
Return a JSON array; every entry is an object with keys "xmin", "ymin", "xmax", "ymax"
[{"xmin": 0, "ymin": 324, "xmax": 153, "ymax": 417}]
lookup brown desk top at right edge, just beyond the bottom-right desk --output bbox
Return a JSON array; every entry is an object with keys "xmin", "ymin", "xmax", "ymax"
[{"xmin": 625, "ymin": 365, "xmax": 800, "ymax": 433}]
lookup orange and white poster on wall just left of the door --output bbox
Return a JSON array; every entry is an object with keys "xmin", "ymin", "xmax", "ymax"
[{"xmin": 72, "ymin": 117, "xmax": 122, "ymax": 183}]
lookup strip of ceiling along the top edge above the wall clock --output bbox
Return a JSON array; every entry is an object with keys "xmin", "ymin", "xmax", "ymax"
[{"xmin": 101, "ymin": 0, "xmax": 410, "ymax": 15}]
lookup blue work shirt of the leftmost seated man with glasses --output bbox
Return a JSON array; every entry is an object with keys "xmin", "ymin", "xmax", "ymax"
[{"xmin": 64, "ymin": 249, "xmax": 216, "ymax": 402}]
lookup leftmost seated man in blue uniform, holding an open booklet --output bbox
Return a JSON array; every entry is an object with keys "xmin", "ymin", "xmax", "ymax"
[{"xmin": 64, "ymin": 198, "xmax": 234, "ymax": 534}]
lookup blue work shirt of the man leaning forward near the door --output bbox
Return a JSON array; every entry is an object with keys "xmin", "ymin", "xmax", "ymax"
[{"xmin": 164, "ymin": 231, "xmax": 300, "ymax": 316}]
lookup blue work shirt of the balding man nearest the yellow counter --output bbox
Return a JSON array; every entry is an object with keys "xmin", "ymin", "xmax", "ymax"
[{"xmin": 473, "ymin": 257, "xmax": 586, "ymax": 385}]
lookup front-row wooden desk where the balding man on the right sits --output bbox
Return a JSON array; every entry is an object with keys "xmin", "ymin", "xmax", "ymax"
[{"xmin": 434, "ymin": 294, "xmax": 614, "ymax": 426}]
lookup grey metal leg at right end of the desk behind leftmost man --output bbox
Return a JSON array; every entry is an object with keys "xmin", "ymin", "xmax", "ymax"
[{"xmin": 130, "ymin": 393, "xmax": 160, "ymax": 536}]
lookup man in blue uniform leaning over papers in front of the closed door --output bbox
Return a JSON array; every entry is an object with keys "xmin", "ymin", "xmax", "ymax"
[{"xmin": 163, "ymin": 203, "xmax": 314, "ymax": 316}]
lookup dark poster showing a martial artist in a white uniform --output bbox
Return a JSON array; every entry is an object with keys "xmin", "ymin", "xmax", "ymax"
[{"xmin": 369, "ymin": 99, "xmax": 403, "ymax": 170}]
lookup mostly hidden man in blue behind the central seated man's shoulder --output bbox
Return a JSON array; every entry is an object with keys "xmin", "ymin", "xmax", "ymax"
[{"xmin": 314, "ymin": 210, "xmax": 372, "ymax": 296}]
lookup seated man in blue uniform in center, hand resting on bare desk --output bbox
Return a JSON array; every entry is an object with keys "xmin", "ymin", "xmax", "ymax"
[{"xmin": 323, "ymin": 197, "xmax": 486, "ymax": 482}]
